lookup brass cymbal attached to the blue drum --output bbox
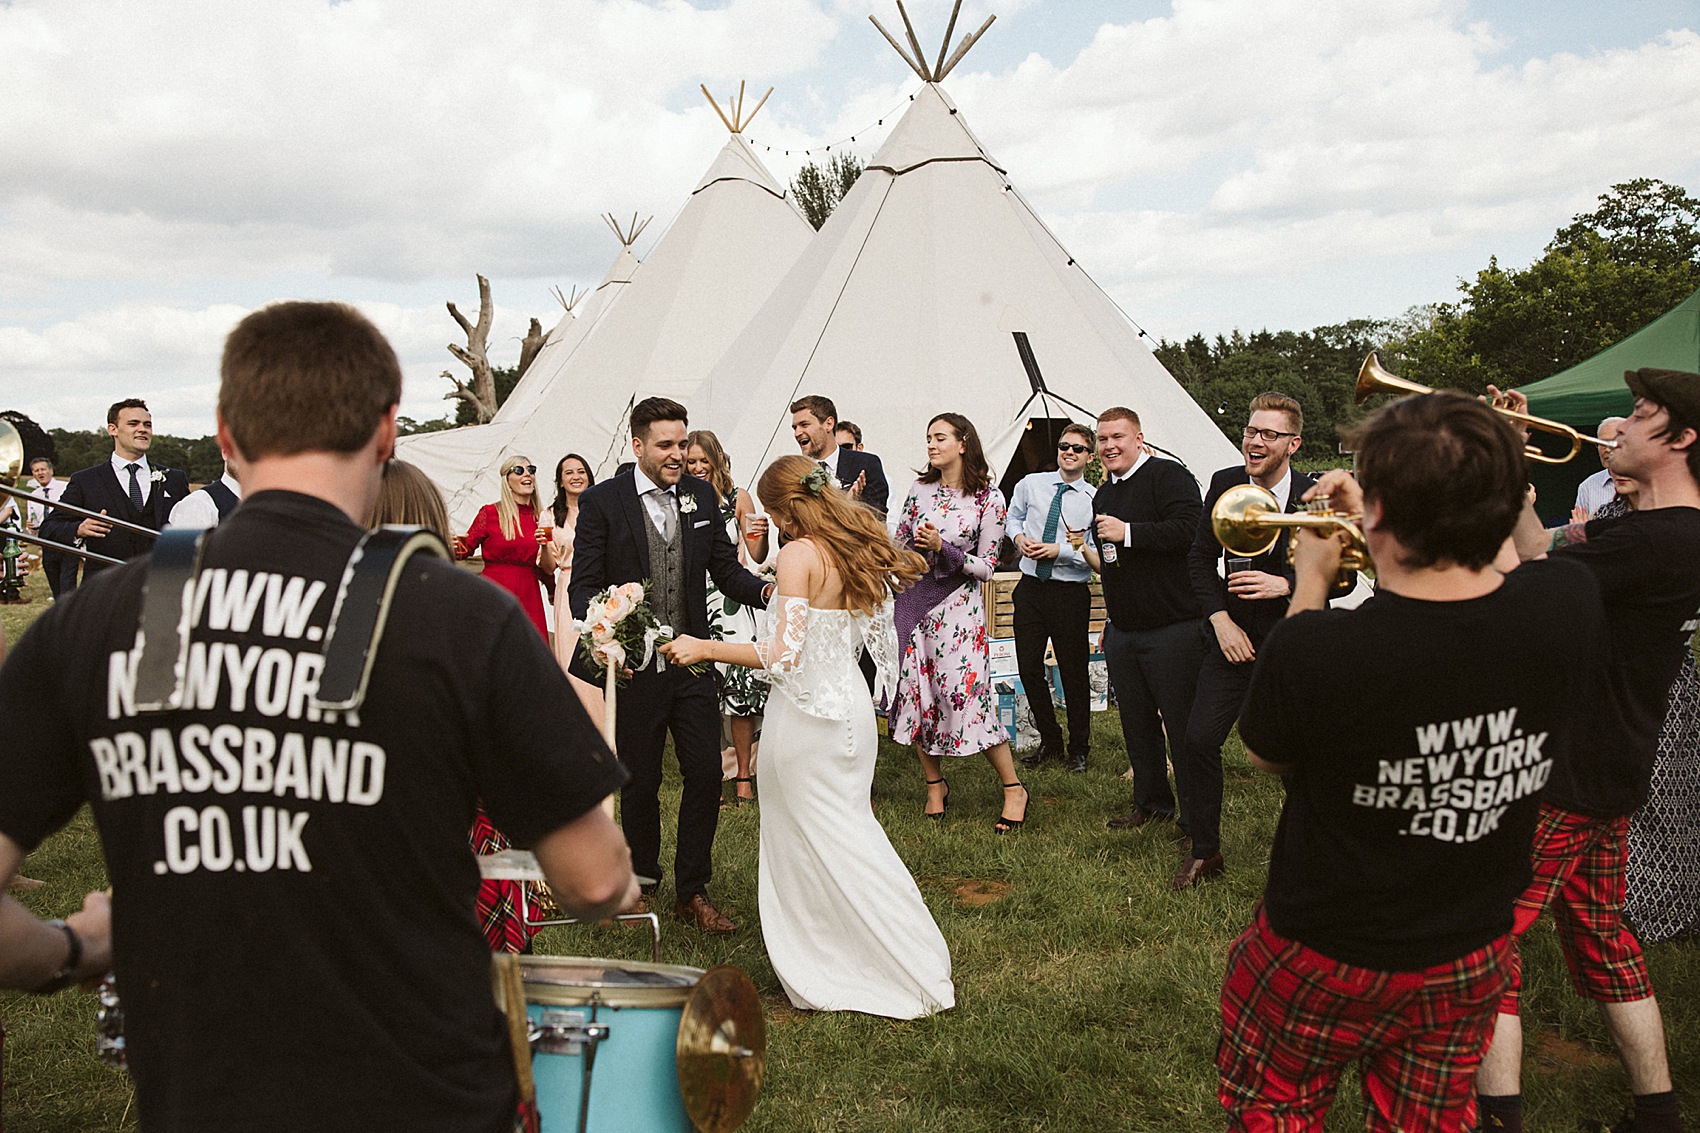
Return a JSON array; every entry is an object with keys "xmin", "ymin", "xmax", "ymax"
[{"xmin": 678, "ymin": 965, "xmax": 767, "ymax": 1133}]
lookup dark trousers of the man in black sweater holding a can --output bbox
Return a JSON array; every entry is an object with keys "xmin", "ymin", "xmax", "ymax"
[{"xmin": 1103, "ymin": 618, "xmax": 1210, "ymax": 828}]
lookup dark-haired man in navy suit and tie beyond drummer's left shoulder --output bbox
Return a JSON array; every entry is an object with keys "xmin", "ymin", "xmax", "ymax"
[{"xmin": 41, "ymin": 398, "xmax": 189, "ymax": 578}]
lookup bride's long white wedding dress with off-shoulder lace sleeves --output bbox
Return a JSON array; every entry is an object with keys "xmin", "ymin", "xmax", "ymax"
[{"xmin": 757, "ymin": 597, "xmax": 955, "ymax": 1019}]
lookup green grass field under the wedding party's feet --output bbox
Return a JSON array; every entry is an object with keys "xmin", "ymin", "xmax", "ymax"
[{"xmin": 0, "ymin": 595, "xmax": 1700, "ymax": 1133}]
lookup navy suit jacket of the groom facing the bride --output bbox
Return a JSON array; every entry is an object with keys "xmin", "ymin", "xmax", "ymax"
[{"xmin": 566, "ymin": 473, "xmax": 767, "ymax": 663}]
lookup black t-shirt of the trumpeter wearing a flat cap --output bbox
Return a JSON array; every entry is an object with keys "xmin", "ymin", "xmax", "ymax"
[{"xmin": 1547, "ymin": 507, "xmax": 1700, "ymax": 818}]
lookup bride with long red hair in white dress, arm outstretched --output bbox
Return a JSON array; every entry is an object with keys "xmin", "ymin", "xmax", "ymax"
[{"xmin": 661, "ymin": 456, "xmax": 955, "ymax": 1019}]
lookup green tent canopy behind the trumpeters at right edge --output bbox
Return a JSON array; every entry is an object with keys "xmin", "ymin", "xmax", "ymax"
[{"xmin": 1522, "ymin": 291, "xmax": 1700, "ymax": 524}]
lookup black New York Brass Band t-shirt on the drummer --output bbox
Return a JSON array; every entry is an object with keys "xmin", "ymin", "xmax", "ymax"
[{"xmin": 0, "ymin": 492, "xmax": 626, "ymax": 1133}]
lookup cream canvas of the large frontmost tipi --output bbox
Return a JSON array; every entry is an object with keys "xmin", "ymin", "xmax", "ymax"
[{"xmin": 699, "ymin": 83, "xmax": 1239, "ymax": 498}]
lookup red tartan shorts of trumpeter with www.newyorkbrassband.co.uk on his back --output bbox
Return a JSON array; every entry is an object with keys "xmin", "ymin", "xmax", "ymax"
[{"xmin": 1216, "ymin": 905, "xmax": 1513, "ymax": 1133}]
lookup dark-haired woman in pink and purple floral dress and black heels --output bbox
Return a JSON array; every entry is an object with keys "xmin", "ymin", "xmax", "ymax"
[{"xmin": 889, "ymin": 413, "xmax": 1027, "ymax": 834}]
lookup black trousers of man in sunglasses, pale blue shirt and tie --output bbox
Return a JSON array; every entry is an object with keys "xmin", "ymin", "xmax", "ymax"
[{"xmin": 1015, "ymin": 575, "xmax": 1091, "ymax": 757}]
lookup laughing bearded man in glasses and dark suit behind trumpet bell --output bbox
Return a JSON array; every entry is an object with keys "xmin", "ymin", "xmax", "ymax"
[{"xmin": 1170, "ymin": 393, "xmax": 1316, "ymax": 890}]
